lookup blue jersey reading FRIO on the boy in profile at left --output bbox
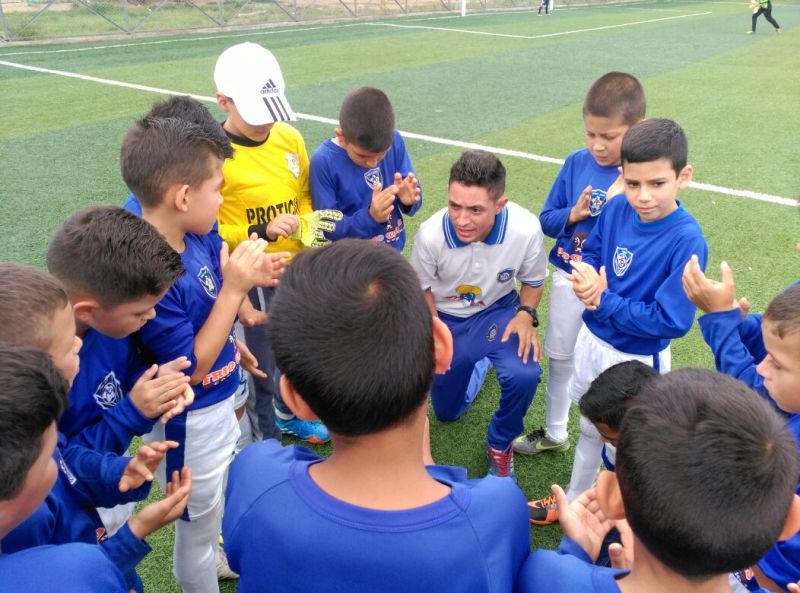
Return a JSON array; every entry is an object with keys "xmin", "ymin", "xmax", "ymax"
[{"xmin": 140, "ymin": 234, "xmax": 239, "ymax": 410}]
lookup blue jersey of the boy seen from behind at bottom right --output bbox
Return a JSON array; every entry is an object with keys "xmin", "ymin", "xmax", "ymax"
[{"xmin": 515, "ymin": 536, "xmax": 628, "ymax": 593}]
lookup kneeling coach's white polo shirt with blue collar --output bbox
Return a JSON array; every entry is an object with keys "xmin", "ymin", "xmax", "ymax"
[{"xmin": 411, "ymin": 202, "xmax": 547, "ymax": 317}]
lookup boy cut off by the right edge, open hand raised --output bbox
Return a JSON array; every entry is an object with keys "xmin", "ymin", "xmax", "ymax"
[{"xmin": 683, "ymin": 258, "xmax": 800, "ymax": 590}]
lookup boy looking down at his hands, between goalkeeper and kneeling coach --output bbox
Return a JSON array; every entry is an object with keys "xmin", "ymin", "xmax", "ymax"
[{"xmin": 310, "ymin": 87, "xmax": 422, "ymax": 251}]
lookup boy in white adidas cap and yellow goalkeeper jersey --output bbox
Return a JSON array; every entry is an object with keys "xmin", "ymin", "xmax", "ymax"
[{"xmin": 214, "ymin": 42, "xmax": 329, "ymax": 443}]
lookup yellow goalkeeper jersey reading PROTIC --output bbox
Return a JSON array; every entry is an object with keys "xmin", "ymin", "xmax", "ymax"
[{"xmin": 219, "ymin": 122, "xmax": 312, "ymax": 254}]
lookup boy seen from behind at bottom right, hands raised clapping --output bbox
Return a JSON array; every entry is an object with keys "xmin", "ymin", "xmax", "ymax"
[{"xmin": 517, "ymin": 369, "xmax": 800, "ymax": 593}]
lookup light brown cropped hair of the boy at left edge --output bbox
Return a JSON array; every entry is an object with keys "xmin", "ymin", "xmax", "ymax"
[{"xmin": 0, "ymin": 262, "xmax": 69, "ymax": 350}]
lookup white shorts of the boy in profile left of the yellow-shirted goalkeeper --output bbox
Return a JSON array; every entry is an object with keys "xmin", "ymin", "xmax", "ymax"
[{"xmin": 144, "ymin": 395, "xmax": 240, "ymax": 520}]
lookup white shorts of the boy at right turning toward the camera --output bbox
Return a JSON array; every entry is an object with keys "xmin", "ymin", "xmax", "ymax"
[{"xmin": 567, "ymin": 324, "xmax": 672, "ymax": 404}]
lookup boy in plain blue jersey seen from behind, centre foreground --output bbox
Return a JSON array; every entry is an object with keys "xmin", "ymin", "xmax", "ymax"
[{"xmin": 223, "ymin": 239, "xmax": 530, "ymax": 593}]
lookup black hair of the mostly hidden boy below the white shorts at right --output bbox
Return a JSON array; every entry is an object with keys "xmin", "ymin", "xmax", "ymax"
[{"xmin": 578, "ymin": 360, "xmax": 658, "ymax": 430}]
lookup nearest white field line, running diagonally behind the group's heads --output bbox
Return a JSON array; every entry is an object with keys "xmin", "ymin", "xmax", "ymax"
[{"xmin": 0, "ymin": 60, "xmax": 800, "ymax": 206}]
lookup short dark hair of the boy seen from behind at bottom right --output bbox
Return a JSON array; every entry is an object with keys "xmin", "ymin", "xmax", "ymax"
[{"xmin": 616, "ymin": 369, "xmax": 798, "ymax": 581}]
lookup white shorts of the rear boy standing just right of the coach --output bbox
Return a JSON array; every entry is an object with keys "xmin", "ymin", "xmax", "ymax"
[{"xmin": 544, "ymin": 268, "xmax": 586, "ymax": 360}]
